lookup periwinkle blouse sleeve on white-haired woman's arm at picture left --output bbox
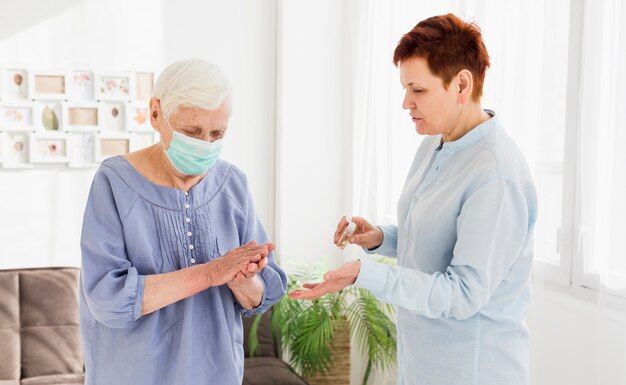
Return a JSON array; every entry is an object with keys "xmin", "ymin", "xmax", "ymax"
[{"xmin": 81, "ymin": 170, "xmax": 144, "ymax": 328}]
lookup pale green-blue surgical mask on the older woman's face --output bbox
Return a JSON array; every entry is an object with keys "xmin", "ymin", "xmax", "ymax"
[{"xmin": 161, "ymin": 110, "xmax": 223, "ymax": 175}]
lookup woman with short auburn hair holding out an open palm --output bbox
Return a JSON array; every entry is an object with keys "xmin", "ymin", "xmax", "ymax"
[{"xmin": 290, "ymin": 14, "xmax": 537, "ymax": 385}]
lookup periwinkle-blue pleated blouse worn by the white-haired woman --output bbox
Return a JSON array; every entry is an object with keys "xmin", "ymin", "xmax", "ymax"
[{"xmin": 80, "ymin": 157, "xmax": 286, "ymax": 385}]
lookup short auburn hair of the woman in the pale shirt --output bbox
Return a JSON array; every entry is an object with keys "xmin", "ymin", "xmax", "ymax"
[{"xmin": 393, "ymin": 13, "xmax": 489, "ymax": 102}]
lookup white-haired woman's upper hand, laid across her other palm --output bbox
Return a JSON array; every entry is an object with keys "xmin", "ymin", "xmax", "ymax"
[{"xmin": 206, "ymin": 241, "xmax": 275, "ymax": 286}]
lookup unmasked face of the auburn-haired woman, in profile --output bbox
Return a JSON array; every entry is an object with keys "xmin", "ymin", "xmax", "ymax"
[{"xmin": 400, "ymin": 57, "xmax": 461, "ymax": 135}]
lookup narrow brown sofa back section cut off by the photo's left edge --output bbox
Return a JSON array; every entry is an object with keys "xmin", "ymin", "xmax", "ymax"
[{"xmin": 0, "ymin": 271, "xmax": 20, "ymax": 384}]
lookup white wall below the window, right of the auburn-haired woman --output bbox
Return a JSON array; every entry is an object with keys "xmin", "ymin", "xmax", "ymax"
[{"xmin": 527, "ymin": 282, "xmax": 626, "ymax": 385}]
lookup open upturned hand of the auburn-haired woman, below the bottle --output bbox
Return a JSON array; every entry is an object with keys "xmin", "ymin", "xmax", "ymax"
[{"xmin": 289, "ymin": 261, "xmax": 361, "ymax": 299}]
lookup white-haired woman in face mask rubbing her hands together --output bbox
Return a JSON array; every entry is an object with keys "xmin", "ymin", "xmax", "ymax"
[{"xmin": 80, "ymin": 60, "xmax": 286, "ymax": 385}]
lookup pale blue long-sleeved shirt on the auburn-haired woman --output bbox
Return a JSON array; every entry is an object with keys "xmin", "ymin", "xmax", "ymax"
[{"xmin": 355, "ymin": 111, "xmax": 537, "ymax": 385}]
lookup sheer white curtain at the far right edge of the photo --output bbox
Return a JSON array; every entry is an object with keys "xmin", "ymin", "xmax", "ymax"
[{"xmin": 577, "ymin": 0, "xmax": 626, "ymax": 297}]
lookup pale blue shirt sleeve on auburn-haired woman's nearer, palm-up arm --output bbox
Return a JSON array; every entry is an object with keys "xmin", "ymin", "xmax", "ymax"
[{"xmin": 355, "ymin": 179, "xmax": 529, "ymax": 319}]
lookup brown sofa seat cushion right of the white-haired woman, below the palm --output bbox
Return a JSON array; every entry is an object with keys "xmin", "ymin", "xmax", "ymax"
[{"xmin": 243, "ymin": 357, "xmax": 308, "ymax": 385}]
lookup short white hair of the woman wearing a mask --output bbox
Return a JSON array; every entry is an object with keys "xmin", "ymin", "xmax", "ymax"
[{"xmin": 152, "ymin": 59, "xmax": 232, "ymax": 116}]
